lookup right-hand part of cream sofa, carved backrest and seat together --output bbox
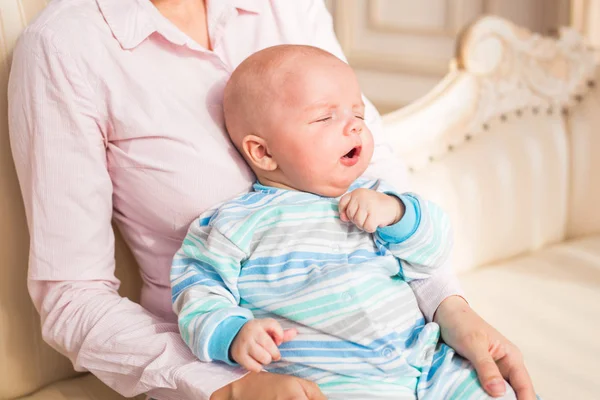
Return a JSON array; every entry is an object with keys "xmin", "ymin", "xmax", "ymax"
[{"xmin": 384, "ymin": 17, "xmax": 600, "ymax": 400}]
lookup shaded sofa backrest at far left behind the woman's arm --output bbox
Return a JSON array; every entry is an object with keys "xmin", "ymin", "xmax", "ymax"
[{"xmin": 0, "ymin": 0, "xmax": 140, "ymax": 399}]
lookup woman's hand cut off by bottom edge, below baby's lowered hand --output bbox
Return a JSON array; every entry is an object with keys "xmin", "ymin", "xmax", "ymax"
[{"xmin": 210, "ymin": 371, "xmax": 327, "ymax": 400}]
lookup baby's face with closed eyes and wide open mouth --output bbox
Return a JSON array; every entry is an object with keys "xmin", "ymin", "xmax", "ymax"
[{"xmin": 265, "ymin": 57, "xmax": 373, "ymax": 197}]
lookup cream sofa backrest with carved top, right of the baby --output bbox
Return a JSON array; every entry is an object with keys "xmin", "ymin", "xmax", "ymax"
[{"xmin": 384, "ymin": 17, "xmax": 600, "ymax": 271}]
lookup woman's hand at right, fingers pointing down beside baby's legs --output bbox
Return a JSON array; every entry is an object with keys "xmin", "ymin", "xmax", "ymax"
[{"xmin": 434, "ymin": 296, "xmax": 536, "ymax": 400}]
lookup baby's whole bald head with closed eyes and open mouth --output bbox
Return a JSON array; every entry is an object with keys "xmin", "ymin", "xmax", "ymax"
[{"xmin": 223, "ymin": 45, "xmax": 373, "ymax": 197}]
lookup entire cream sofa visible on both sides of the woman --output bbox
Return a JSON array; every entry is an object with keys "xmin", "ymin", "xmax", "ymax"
[{"xmin": 0, "ymin": 0, "xmax": 600, "ymax": 400}]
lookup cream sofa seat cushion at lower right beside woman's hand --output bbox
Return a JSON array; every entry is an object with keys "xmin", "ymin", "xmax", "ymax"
[{"xmin": 460, "ymin": 236, "xmax": 600, "ymax": 400}]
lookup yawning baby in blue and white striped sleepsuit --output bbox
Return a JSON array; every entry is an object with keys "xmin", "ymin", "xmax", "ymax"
[{"xmin": 171, "ymin": 45, "xmax": 514, "ymax": 400}]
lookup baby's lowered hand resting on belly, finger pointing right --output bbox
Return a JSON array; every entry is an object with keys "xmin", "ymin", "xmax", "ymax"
[{"xmin": 229, "ymin": 318, "xmax": 298, "ymax": 372}]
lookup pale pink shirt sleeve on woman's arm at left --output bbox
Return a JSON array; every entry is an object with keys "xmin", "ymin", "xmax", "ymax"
[{"xmin": 8, "ymin": 31, "xmax": 244, "ymax": 400}]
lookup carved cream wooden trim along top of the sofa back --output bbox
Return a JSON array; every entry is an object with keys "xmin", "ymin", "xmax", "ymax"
[{"xmin": 384, "ymin": 17, "xmax": 600, "ymax": 171}]
